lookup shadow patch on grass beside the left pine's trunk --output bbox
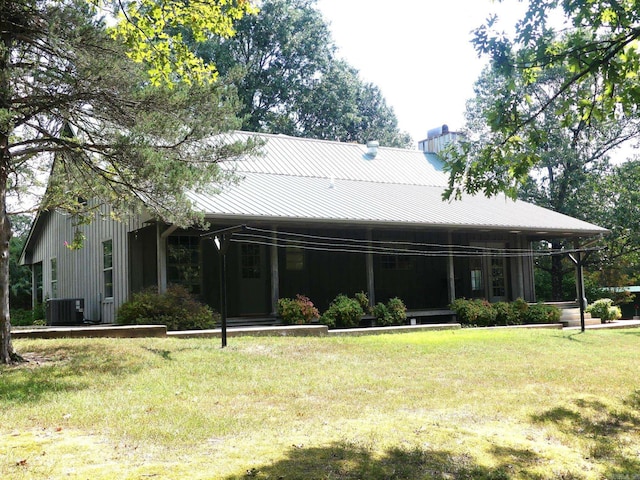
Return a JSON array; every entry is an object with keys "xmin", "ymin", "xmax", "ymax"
[{"xmin": 0, "ymin": 343, "xmax": 142, "ymax": 405}]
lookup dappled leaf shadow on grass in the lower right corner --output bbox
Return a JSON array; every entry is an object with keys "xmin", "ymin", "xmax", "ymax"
[{"xmin": 532, "ymin": 390, "xmax": 640, "ymax": 480}]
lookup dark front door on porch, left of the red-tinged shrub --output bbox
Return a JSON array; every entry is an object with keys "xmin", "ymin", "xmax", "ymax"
[{"xmin": 238, "ymin": 243, "xmax": 270, "ymax": 315}]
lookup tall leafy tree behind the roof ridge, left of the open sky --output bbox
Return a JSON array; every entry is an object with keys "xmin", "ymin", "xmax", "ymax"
[{"xmin": 196, "ymin": 0, "xmax": 411, "ymax": 147}]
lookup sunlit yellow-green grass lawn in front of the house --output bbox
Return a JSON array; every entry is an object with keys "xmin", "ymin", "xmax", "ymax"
[{"xmin": 0, "ymin": 329, "xmax": 640, "ymax": 480}]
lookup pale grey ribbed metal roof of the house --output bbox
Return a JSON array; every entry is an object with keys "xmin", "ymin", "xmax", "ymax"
[{"xmin": 191, "ymin": 134, "xmax": 607, "ymax": 235}]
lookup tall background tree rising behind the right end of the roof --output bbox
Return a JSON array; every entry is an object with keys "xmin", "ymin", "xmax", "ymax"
[{"xmin": 460, "ymin": 62, "xmax": 640, "ymax": 300}]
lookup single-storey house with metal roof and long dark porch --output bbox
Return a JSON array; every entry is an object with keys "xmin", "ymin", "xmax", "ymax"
[{"xmin": 22, "ymin": 126, "xmax": 606, "ymax": 323}]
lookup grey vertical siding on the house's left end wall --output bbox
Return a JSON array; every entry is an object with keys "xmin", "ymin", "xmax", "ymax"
[{"xmin": 27, "ymin": 208, "xmax": 142, "ymax": 323}]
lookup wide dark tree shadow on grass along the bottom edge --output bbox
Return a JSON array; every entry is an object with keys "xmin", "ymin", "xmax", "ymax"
[{"xmin": 221, "ymin": 443, "xmax": 568, "ymax": 480}]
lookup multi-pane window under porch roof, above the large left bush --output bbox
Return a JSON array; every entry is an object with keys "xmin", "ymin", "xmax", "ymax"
[{"xmin": 167, "ymin": 235, "xmax": 200, "ymax": 295}]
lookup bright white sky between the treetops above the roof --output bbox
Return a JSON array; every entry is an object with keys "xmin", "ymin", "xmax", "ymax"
[{"xmin": 316, "ymin": 0, "xmax": 525, "ymax": 145}]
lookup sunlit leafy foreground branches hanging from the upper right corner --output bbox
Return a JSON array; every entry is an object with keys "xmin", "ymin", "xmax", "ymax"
[{"xmin": 447, "ymin": 0, "xmax": 640, "ymax": 197}]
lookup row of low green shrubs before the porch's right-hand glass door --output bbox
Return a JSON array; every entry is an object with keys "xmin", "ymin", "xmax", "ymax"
[{"xmin": 449, "ymin": 298, "xmax": 561, "ymax": 327}]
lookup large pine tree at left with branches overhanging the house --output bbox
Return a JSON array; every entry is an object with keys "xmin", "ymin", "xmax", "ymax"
[{"xmin": 0, "ymin": 0, "xmax": 255, "ymax": 363}]
